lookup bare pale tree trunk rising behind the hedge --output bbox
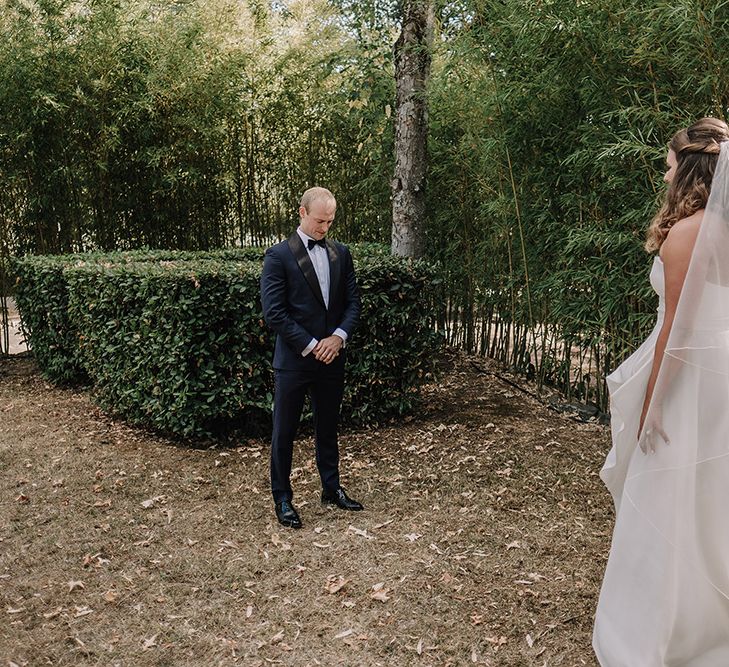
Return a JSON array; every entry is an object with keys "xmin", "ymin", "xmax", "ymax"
[{"xmin": 392, "ymin": 0, "xmax": 434, "ymax": 257}]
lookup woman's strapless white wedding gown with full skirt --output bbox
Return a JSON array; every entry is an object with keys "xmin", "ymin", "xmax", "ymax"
[{"xmin": 593, "ymin": 257, "xmax": 729, "ymax": 667}]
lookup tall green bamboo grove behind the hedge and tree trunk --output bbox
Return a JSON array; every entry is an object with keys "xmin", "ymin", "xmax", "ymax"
[{"xmin": 0, "ymin": 0, "xmax": 729, "ymax": 409}]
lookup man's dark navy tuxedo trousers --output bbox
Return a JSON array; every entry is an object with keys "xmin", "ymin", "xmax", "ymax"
[{"xmin": 271, "ymin": 360, "xmax": 344, "ymax": 503}]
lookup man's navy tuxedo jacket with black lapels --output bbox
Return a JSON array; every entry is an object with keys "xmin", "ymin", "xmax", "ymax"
[{"xmin": 261, "ymin": 232, "xmax": 361, "ymax": 370}]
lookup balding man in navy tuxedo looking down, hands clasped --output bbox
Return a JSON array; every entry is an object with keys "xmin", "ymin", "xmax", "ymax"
[{"xmin": 261, "ymin": 188, "xmax": 363, "ymax": 528}]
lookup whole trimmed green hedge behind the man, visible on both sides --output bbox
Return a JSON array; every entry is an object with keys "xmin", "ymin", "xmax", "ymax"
[{"xmin": 15, "ymin": 244, "xmax": 441, "ymax": 436}]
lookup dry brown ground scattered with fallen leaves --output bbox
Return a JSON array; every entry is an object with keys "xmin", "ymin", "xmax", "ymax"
[{"xmin": 0, "ymin": 355, "xmax": 613, "ymax": 667}]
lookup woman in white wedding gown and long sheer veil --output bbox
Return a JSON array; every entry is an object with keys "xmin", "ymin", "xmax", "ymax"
[{"xmin": 593, "ymin": 118, "xmax": 729, "ymax": 667}]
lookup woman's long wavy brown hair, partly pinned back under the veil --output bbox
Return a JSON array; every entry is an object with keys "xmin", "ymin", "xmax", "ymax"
[{"xmin": 645, "ymin": 118, "xmax": 729, "ymax": 252}]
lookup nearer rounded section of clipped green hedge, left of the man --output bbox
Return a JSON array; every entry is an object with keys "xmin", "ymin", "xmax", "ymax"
[{"xmin": 65, "ymin": 259, "xmax": 272, "ymax": 436}]
